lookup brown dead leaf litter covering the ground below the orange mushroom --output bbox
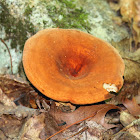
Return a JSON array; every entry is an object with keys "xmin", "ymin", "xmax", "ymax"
[{"xmin": 0, "ymin": 75, "xmax": 139, "ymax": 140}]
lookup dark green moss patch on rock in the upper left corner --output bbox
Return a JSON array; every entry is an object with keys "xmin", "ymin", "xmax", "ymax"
[{"xmin": 0, "ymin": 0, "xmax": 35, "ymax": 50}]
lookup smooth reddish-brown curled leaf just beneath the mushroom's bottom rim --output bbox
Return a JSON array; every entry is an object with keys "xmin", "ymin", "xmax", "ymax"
[{"xmin": 49, "ymin": 104, "xmax": 120, "ymax": 129}]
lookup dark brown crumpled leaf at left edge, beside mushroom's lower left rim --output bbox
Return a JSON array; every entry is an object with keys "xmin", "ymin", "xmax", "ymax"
[{"xmin": 0, "ymin": 75, "xmax": 33, "ymax": 106}]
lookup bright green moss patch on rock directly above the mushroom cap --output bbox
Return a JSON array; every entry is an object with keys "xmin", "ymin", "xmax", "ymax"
[{"xmin": 43, "ymin": 0, "xmax": 91, "ymax": 32}]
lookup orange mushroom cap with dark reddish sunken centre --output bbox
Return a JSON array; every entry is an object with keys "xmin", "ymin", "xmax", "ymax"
[{"xmin": 23, "ymin": 28, "xmax": 125, "ymax": 104}]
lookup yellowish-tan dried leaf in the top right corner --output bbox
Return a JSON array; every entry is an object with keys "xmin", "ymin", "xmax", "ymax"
[{"xmin": 109, "ymin": 0, "xmax": 140, "ymax": 49}]
